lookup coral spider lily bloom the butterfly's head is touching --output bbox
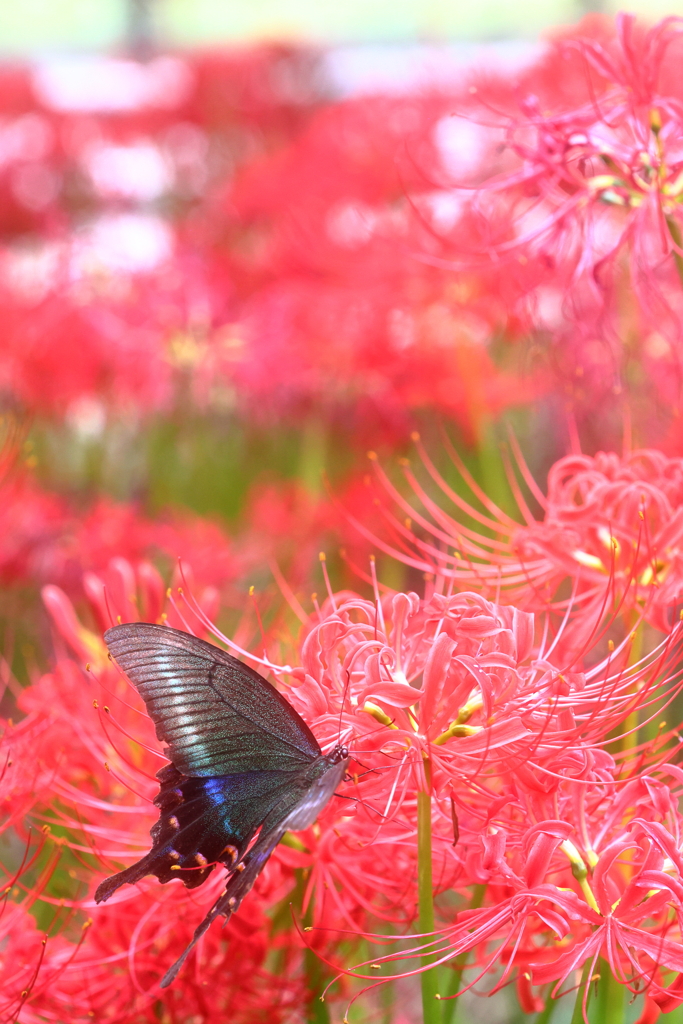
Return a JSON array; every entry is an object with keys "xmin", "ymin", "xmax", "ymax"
[{"xmin": 244, "ymin": 569, "xmax": 680, "ymax": 983}]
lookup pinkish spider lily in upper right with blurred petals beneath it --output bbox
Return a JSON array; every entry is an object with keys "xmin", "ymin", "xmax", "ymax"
[{"xmin": 432, "ymin": 14, "xmax": 683, "ymax": 423}]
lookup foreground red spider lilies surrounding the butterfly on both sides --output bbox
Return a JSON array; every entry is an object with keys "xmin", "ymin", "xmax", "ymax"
[{"xmin": 5, "ymin": 520, "xmax": 683, "ymax": 1020}]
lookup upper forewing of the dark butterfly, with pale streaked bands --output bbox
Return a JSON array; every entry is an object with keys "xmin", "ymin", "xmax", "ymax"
[{"xmin": 104, "ymin": 623, "xmax": 321, "ymax": 776}]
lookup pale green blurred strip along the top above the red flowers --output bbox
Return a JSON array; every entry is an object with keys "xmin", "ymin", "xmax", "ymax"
[{"xmin": 0, "ymin": 0, "xmax": 683, "ymax": 54}]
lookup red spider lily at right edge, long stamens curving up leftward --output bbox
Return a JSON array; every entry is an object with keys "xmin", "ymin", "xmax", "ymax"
[{"xmin": 352, "ymin": 435, "xmax": 683, "ymax": 643}]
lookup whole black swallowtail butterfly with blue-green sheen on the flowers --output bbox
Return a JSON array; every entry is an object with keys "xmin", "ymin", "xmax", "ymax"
[{"xmin": 95, "ymin": 623, "xmax": 348, "ymax": 988}]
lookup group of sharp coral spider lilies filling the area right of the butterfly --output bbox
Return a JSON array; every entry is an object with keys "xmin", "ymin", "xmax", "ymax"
[{"xmin": 274, "ymin": 573, "xmax": 683, "ymax": 1012}]
